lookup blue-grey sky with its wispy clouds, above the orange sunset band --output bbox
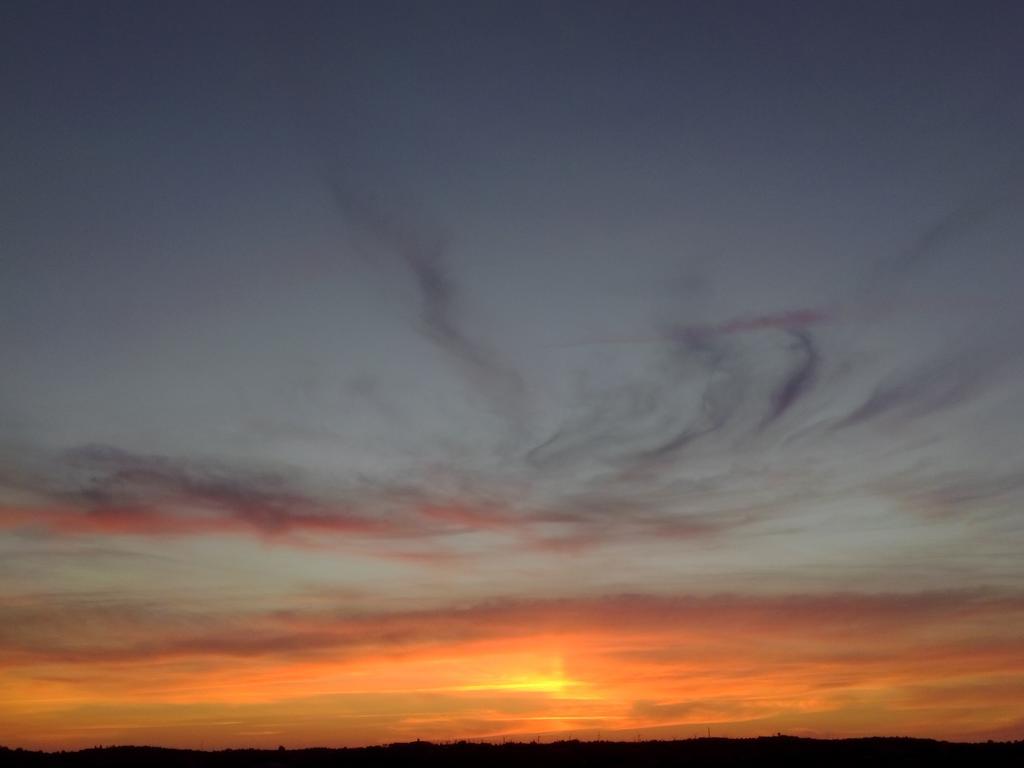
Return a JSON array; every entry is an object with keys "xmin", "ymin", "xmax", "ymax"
[{"xmin": 0, "ymin": 2, "xmax": 1024, "ymax": 618}]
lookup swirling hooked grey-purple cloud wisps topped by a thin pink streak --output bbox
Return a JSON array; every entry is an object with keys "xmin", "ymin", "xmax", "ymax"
[{"xmin": 526, "ymin": 309, "xmax": 831, "ymax": 471}]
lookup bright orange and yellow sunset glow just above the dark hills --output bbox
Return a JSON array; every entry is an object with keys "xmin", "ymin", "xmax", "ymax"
[{"xmin": 0, "ymin": 601, "xmax": 1024, "ymax": 749}]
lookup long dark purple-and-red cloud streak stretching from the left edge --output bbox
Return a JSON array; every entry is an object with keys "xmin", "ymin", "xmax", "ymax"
[{"xmin": 0, "ymin": 444, "xmax": 753, "ymax": 564}]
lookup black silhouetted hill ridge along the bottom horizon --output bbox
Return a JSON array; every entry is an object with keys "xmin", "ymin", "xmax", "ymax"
[{"xmin": 0, "ymin": 736, "xmax": 1024, "ymax": 768}]
